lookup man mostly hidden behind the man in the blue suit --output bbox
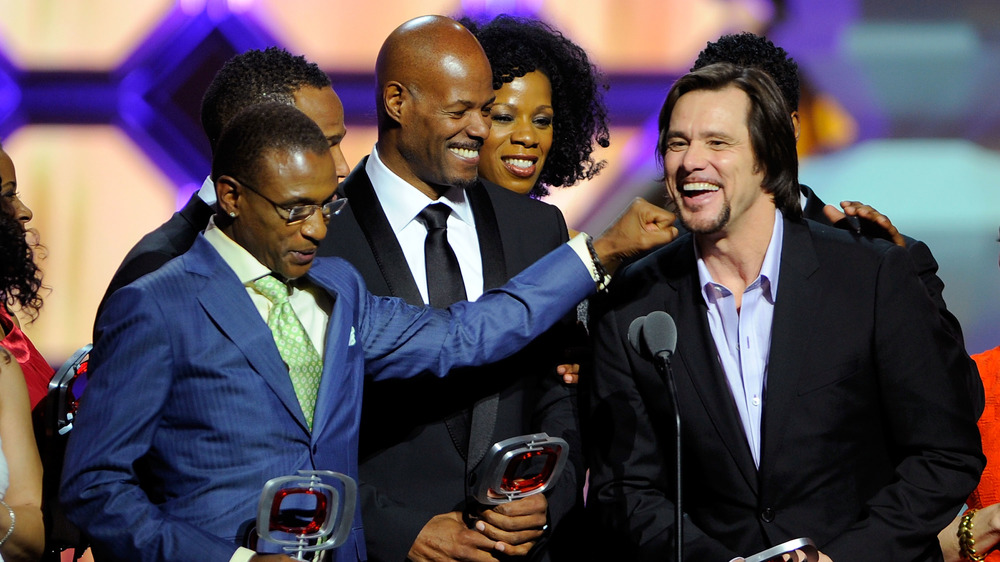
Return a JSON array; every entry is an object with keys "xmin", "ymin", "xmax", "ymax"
[{"xmin": 95, "ymin": 47, "xmax": 350, "ymax": 328}]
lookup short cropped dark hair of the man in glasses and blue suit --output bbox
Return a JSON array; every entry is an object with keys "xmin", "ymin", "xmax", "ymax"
[{"xmin": 212, "ymin": 102, "xmax": 330, "ymax": 182}]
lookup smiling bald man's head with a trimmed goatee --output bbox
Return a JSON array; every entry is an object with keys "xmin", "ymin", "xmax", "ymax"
[{"xmin": 375, "ymin": 16, "xmax": 494, "ymax": 198}]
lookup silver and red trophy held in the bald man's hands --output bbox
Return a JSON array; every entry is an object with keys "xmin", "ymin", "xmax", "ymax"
[{"xmin": 472, "ymin": 433, "xmax": 569, "ymax": 505}]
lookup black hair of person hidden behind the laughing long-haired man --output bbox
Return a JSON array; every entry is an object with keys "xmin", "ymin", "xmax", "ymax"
[{"xmin": 691, "ymin": 31, "xmax": 799, "ymax": 111}]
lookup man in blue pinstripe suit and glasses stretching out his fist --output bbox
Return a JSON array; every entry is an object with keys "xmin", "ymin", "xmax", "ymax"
[{"xmin": 61, "ymin": 104, "xmax": 676, "ymax": 562}]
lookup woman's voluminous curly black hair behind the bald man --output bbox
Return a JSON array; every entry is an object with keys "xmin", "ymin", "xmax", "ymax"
[{"xmin": 459, "ymin": 14, "xmax": 610, "ymax": 197}]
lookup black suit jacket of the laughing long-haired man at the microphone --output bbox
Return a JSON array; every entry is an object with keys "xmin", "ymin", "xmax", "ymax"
[{"xmin": 581, "ymin": 215, "xmax": 984, "ymax": 561}]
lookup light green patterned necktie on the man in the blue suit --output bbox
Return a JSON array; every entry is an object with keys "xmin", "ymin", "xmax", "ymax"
[{"xmin": 253, "ymin": 275, "xmax": 323, "ymax": 431}]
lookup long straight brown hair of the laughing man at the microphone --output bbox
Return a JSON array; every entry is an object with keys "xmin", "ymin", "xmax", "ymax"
[{"xmin": 656, "ymin": 63, "xmax": 802, "ymax": 218}]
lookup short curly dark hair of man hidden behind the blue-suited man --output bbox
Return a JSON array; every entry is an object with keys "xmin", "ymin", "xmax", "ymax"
[{"xmin": 201, "ymin": 47, "xmax": 330, "ymax": 150}]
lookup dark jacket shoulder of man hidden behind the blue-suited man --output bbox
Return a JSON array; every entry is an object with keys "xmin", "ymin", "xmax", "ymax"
[{"xmin": 95, "ymin": 192, "xmax": 215, "ymax": 332}]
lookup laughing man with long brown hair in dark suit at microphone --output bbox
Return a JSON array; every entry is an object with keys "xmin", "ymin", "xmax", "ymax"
[{"xmin": 583, "ymin": 64, "xmax": 983, "ymax": 561}]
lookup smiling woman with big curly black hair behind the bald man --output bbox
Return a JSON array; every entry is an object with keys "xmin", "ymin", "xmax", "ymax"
[{"xmin": 461, "ymin": 15, "xmax": 608, "ymax": 197}]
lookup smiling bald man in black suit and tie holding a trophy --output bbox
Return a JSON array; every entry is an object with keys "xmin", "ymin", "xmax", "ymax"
[{"xmin": 320, "ymin": 17, "xmax": 582, "ymax": 561}]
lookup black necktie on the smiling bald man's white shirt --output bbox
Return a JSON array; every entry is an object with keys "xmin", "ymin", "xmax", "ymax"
[{"xmin": 417, "ymin": 203, "xmax": 466, "ymax": 308}]
